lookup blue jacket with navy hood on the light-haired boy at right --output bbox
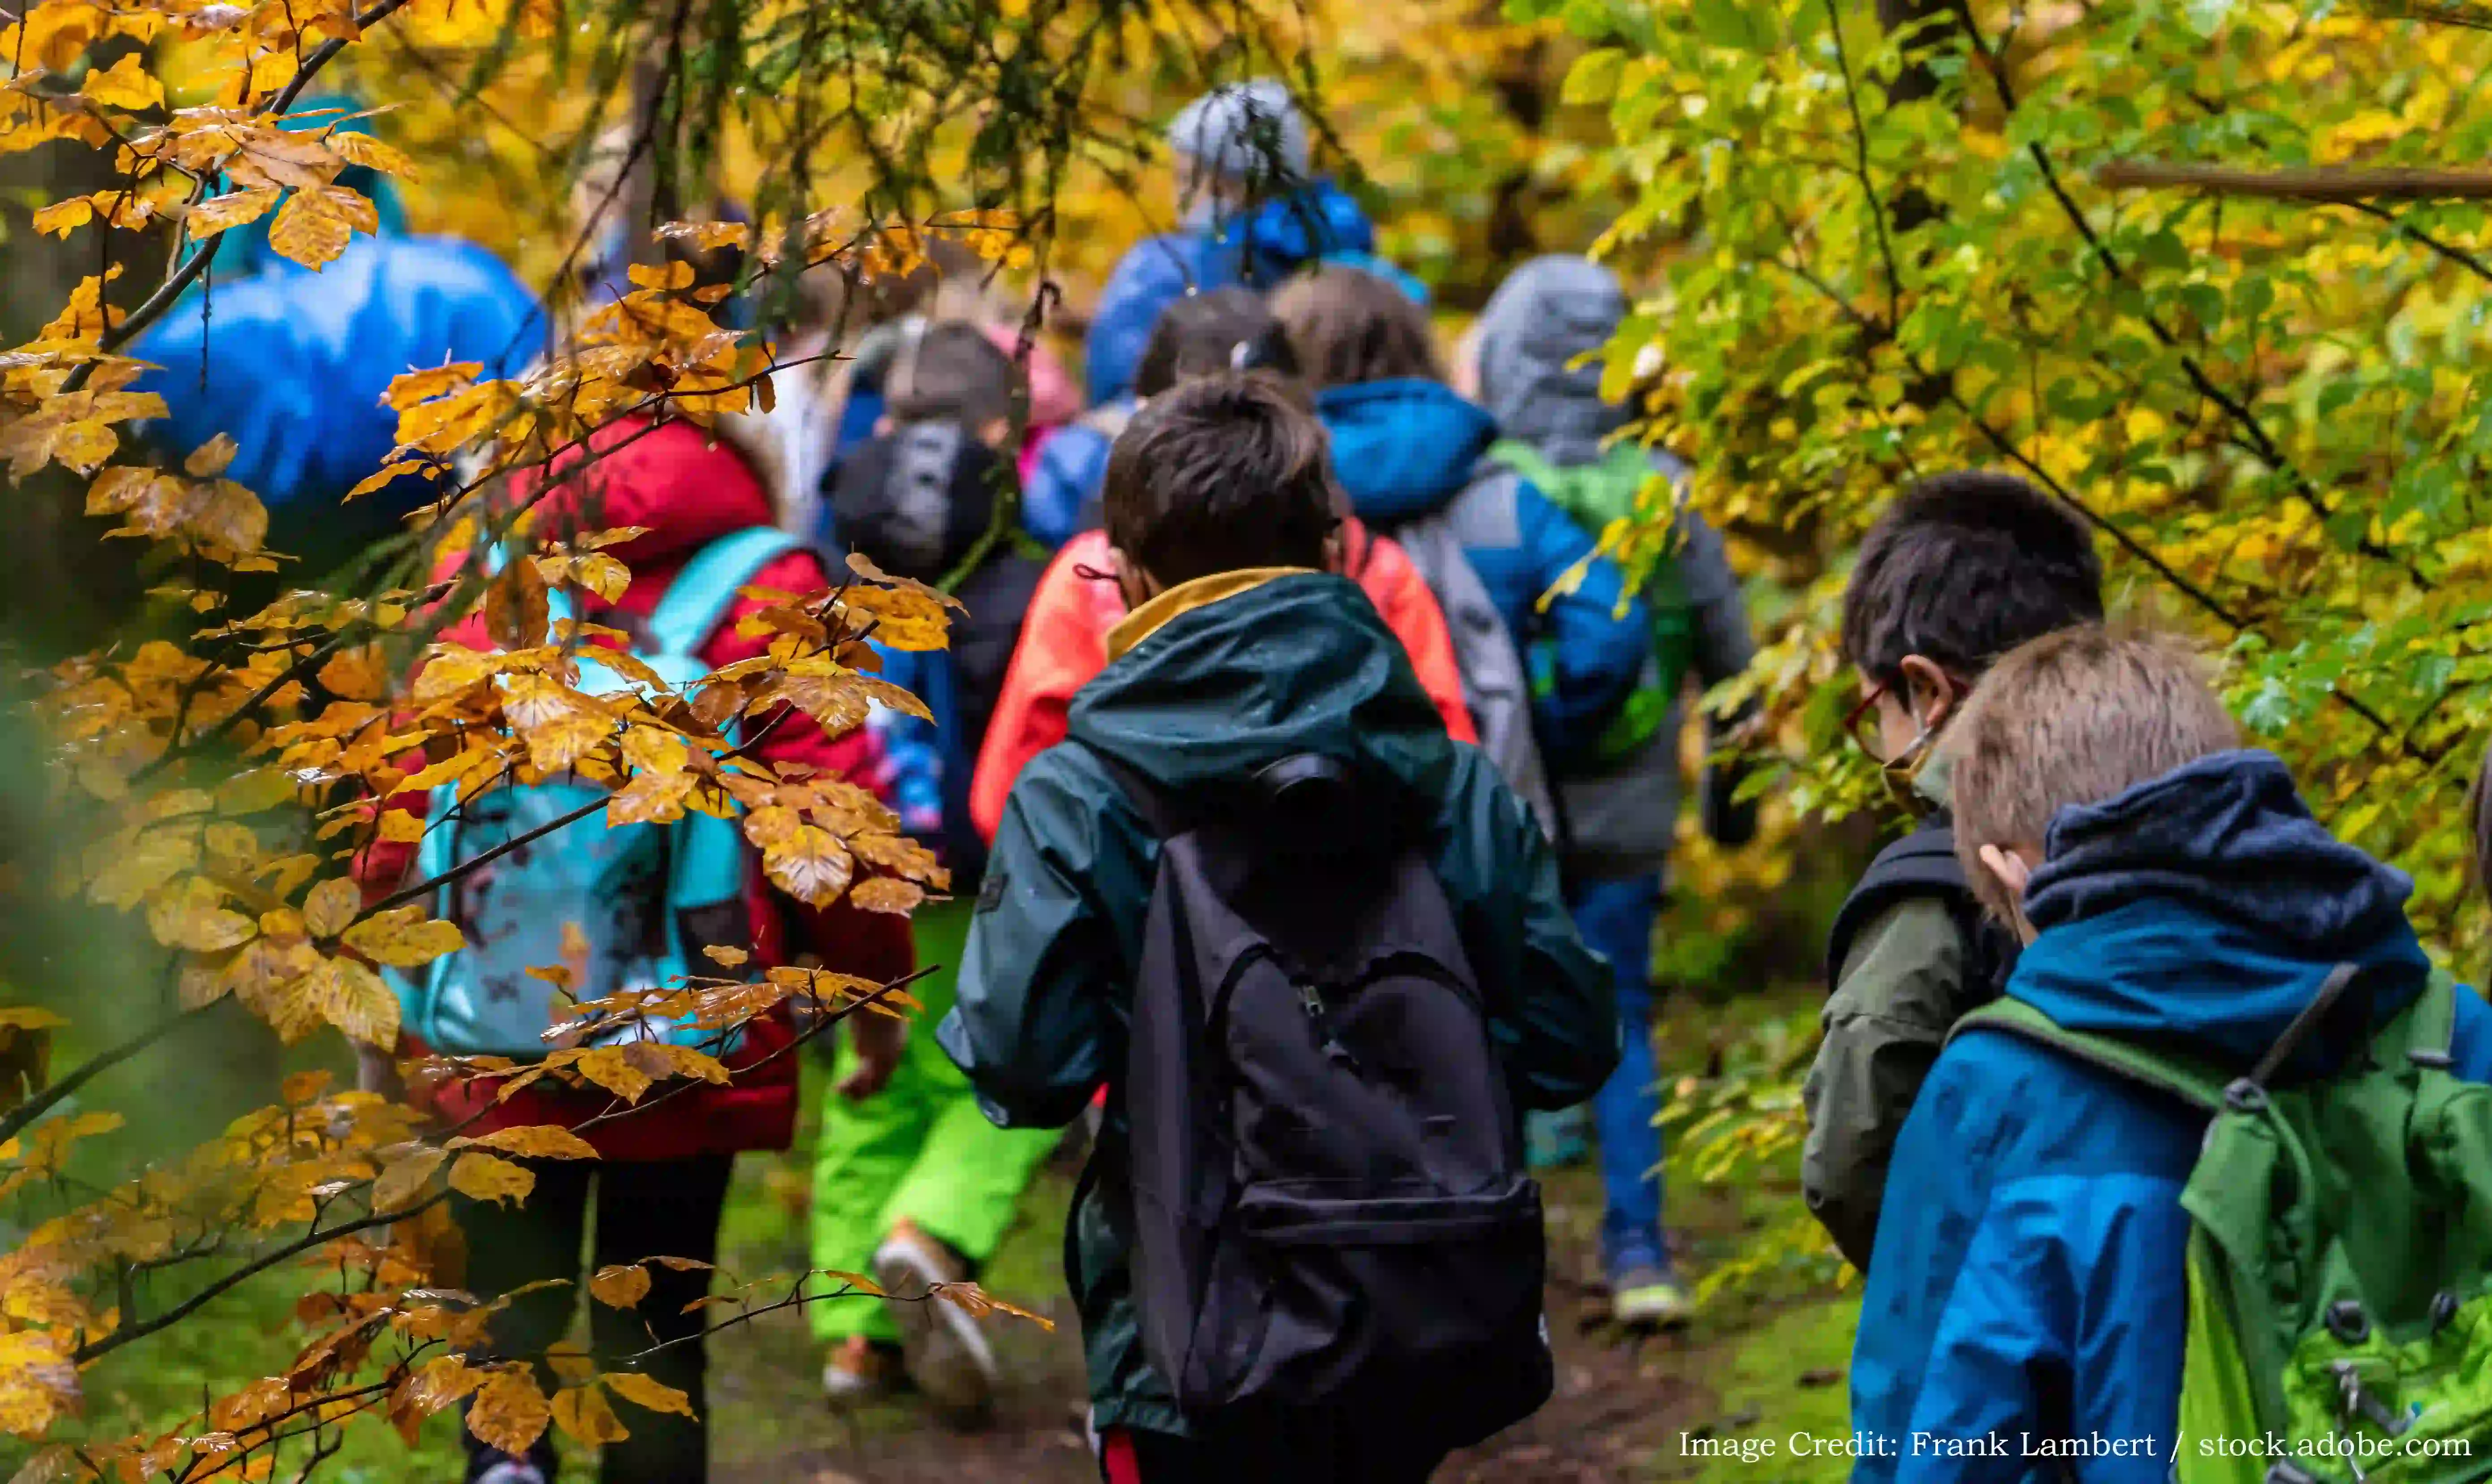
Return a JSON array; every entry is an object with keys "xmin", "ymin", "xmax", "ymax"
[{"xmin": 1852, "ymin": 752, "xmax": 2492, "ymax": 1484}]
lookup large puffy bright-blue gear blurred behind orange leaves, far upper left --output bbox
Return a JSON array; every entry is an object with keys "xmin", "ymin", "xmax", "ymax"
[{"xmin": 130, "ymin": 99, "xmax": 546, "ymax": 575}]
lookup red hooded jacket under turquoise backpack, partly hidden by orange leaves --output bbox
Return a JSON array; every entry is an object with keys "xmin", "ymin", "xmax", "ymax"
[{"xmin": 354, "ymin": 418, "xmax": 915, "ymax": 1160}]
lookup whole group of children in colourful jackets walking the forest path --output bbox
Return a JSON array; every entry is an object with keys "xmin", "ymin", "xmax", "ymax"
[{"xmin": 331, "ymin": 69, "xmax": 2492, "ymax": 1484}]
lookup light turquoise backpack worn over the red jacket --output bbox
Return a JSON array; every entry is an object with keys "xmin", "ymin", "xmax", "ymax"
[{"xmin": 389, "ymin": 528, "xmax": 800, "ymax": 1058}]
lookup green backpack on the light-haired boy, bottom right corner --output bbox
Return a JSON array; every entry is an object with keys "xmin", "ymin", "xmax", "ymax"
[{"xmin": 1954, "ymin": 964, "xmax": 2492, "ymax": 1484}]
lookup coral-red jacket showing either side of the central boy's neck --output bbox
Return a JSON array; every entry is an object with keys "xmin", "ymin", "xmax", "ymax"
[{"xmin": 969, "ymin": 520, "xmax": 1480, "ymax": 841}]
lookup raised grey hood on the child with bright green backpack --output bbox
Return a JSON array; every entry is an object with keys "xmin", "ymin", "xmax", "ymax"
[{"xmin": 1478, "ymin": 256, "xmax": 1627, "ymax": 466}]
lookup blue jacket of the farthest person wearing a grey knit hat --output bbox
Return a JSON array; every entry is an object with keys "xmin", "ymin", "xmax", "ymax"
[{"xmin": 1082, "ymin": 179, "xmax": 1428, "ymax": 406}]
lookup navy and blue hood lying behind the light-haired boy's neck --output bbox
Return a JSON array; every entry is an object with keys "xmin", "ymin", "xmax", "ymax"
[{"xmin": 2008, "ymin": 752, "xmax": 2430, "ymax": 1076}]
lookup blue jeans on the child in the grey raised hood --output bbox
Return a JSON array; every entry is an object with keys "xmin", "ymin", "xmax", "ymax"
[{"xmin": 1567, "ymin": 874, "xmax": 1670, "ymax": 1275}]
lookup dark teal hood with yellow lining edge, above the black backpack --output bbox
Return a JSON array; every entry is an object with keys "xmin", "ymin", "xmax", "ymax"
[{"xmin": 1067, "ymin": 573, "xmax": 1453, "ymax": 792}]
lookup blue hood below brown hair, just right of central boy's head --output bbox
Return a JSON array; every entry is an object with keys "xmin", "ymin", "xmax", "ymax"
[{"xmin": 1316, "ymin": 381, "xmax": 1498, "ymax": 523}]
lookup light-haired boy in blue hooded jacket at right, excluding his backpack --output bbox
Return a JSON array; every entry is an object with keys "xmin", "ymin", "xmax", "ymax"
[{"xmin": 1852, "ymin": 625, "xmax": 2492, "ymax": 1484}]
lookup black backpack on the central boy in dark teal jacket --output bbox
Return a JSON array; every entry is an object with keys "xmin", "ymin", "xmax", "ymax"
[{"xmin": 1114, "ymin": 755, "xmax": 1553, "ymax": 1449}]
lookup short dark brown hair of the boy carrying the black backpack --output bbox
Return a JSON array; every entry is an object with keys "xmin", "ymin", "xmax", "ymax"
[{"xmin": 1102, "ymin": 371, "xmax": 1341, "ymax": 587}]
